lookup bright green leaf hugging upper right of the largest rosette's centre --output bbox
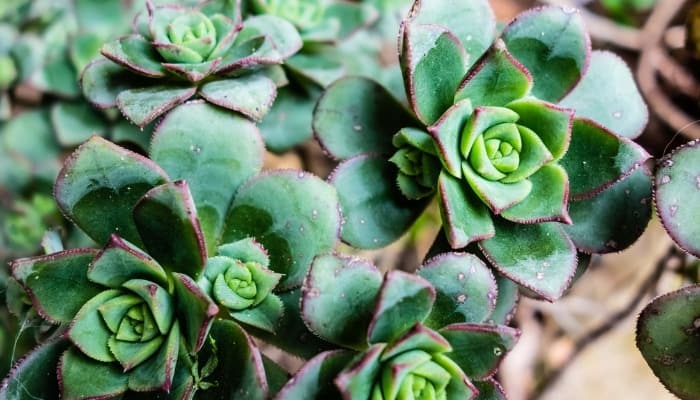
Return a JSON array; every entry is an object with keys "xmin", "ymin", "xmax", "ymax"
[{"xmin": 508, "ymin": 98, "xmax": 574, "ymax": 161}]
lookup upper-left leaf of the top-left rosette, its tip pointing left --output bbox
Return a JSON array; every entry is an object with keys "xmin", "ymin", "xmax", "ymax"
[{"xmin": 100, "ymin": 35, "xmax": 166, "ymax": 78}]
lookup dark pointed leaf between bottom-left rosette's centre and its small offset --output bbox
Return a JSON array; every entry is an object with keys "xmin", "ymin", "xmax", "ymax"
[{"xmin": 173, "ymin": 273, "xmax": 219, "ymax": 354}]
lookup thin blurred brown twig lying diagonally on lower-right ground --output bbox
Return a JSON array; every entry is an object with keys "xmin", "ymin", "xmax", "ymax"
[{"xmin": 529, "ymin": 246, "xmax": 684, "ymax": 399}]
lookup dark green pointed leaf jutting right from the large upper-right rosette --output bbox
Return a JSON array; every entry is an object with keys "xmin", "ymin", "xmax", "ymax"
[{"xmin": 560, "ymin": 119, "xmax": 651, "ymax": 200}]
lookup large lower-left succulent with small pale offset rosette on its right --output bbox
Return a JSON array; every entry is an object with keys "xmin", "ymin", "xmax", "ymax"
[{"xmin": 0, "ymin": 102, "xmax": 340, "ymax": 399}]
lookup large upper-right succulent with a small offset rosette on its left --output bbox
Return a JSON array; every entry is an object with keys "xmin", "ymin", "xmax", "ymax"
[{"xmin": 314, "ymin": 0, "xmax": 651, "ymax": 300}]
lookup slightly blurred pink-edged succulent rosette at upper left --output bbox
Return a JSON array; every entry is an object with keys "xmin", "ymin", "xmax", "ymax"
[{"xmin": 81, "ymin": 0, "xmax": 302, "ymax": 127}]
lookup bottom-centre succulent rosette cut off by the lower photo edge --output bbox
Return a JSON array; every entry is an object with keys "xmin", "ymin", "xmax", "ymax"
[{"xmin": 276, "ymin": 253, "xmax": 519, "ymax": 400}]
